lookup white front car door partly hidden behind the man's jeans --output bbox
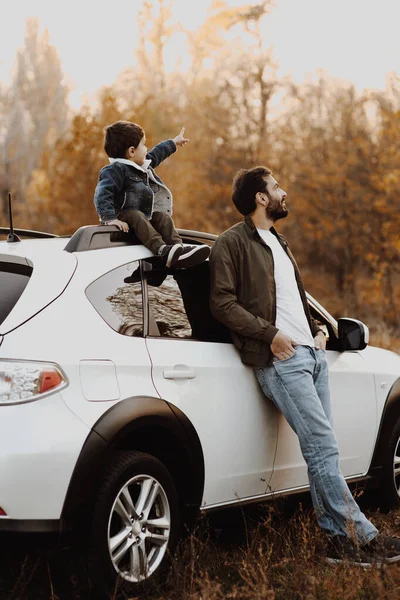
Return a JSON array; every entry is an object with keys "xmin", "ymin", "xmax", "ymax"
[{"xmin": 270, "ymin": 296, "xmax": 376, "ymax": 491}]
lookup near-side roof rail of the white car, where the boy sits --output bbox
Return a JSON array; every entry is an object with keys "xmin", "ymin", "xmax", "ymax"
[{"xmin": 64, "ymin": 225, "xmax": 217, "ymax": 252}]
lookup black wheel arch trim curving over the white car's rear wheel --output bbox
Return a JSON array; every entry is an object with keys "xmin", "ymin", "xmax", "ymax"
[{"xmin": 62, "ymin": 396, "xmax": 205, "ymax": 530}]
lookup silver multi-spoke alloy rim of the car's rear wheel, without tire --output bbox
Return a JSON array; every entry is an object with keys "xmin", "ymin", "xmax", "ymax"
[{"xmin": 107, "ymin": 475, "xmax": 171, "ymax": 583}]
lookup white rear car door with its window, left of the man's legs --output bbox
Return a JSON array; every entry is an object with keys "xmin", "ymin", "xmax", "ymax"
[{"xmin": 145, "ymin": 263, "xmax": 277, "ymax": 507}]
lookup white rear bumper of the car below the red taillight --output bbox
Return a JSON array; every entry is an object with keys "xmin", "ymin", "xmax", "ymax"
[{"xmin": 0, "ymin": 393, "xmax": 89, "ymax": 531}]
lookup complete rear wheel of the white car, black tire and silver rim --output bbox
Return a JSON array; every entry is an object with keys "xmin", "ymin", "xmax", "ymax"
[{"xmin": 87, "ymin": 452, "xmax": 180, "ymax": 598}]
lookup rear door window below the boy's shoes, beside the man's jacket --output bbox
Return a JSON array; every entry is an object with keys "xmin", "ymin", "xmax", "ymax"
[{"xmin": 146, "ymin": 262, "xmax": 231, "ymax": 343}]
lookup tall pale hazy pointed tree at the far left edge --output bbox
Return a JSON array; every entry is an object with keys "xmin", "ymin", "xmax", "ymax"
[{"xmin": 0, "ymin": 19, "xmax": 68, "ymax": 226}]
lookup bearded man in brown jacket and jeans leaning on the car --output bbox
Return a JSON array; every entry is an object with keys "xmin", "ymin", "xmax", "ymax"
[{"xmin": 210, "ymin": 167, "xmax": 400, "ymax": 565}]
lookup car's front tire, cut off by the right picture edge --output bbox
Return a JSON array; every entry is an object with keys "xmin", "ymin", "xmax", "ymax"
[{"xmin": 378, "ymin": 416, "xmax": 400, "ymax": 510}]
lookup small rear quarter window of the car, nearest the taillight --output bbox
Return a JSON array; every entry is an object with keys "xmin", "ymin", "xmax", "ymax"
[{"xmin": 86, "ymin": 261, "xmax": 143, "ymax": 337}]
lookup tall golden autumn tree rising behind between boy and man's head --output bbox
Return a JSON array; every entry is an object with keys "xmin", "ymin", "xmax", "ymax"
[{"xmin": 159, "ymin": 1, "xmax": 276, "ymax": 231}]
